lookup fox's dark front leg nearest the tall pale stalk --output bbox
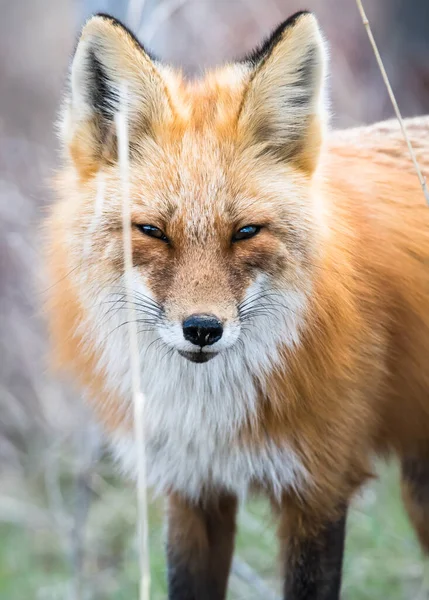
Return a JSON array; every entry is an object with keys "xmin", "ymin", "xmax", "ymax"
[{"xmin": 167, "ymin": 494, "xmax": 237, "ymax": 600}]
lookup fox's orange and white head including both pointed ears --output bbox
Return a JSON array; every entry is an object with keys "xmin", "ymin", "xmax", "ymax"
[{"xmin": 56, "ymin": 12, "xmax": 325, "ymax": 378}]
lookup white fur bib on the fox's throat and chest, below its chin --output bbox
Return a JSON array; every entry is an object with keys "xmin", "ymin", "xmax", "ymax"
[{"xmin": 84, "ymin": 278, "xmax": 308, "ymax": 498}]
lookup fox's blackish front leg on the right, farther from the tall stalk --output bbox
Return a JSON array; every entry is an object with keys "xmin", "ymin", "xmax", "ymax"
[{"xmin": 280, "ymin": 496, "xmax": 347, "ymax": 600}]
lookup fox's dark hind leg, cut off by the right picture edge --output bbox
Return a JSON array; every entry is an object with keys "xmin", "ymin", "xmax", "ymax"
[{"xmin": 401, "ymin": 448, "xmax": 429, "ymax": 555}]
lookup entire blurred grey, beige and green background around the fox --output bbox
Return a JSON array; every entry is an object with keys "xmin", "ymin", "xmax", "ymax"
[{"xmin": 0, "ymin": 0, "xmax": 429, "ymax": 600}]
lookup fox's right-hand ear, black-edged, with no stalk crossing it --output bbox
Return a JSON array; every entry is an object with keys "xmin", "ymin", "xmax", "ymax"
[{"xmin": 238, "ymin": 12, "xmax": 326, "ymax": 172}]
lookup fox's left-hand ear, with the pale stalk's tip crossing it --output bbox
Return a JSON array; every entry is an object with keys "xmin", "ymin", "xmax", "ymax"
[{"xmin": 61, "ymin": 15, "xmax": 171, "ymax": 175}]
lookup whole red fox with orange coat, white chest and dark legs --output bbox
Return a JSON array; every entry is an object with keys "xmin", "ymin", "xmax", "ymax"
[{"xmin": 46, "ymin": 12, "xmax": 429, "ymax": 600}]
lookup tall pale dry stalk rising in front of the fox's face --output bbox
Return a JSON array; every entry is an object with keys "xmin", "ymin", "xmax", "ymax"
[{"xmin": 115, "ymin": 86, "xmax": 150, "ymax": 600}]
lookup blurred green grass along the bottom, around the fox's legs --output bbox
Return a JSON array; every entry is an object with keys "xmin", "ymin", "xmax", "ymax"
[{"xmin": 0, "ymin": 467, "xmax": 423, "ymax": 600}]
